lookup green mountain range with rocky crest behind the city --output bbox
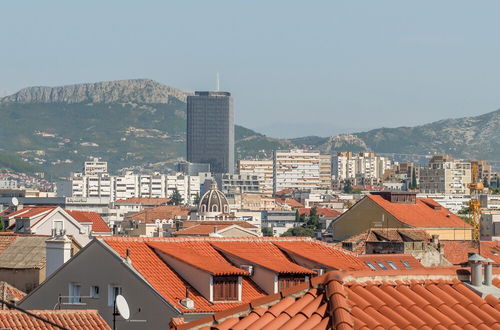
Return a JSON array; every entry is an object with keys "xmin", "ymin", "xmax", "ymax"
[{"xmin": 0, "ymin": 79, "xmax": 500, "ymax": 176}]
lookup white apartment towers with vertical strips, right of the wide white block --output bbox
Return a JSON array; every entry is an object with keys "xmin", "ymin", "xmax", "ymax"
[{"xmin": 332, "ymin": 152, "xmax": 394, "ymax": 181}]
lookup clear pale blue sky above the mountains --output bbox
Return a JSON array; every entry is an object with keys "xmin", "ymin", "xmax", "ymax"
[{"xmin": 0, "ymin": 0, "xmax": 500, "ymax": 137}]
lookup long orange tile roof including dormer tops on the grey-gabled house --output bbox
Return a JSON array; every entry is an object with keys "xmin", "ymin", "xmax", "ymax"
[{"xmin": 100, "ymin": 237, "xmax": 368, "ymax": 313}]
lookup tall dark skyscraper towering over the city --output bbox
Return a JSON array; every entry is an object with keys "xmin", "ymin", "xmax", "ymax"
[{"xmin": 187, "ymin": 92, "xmax": 234, "ymax": 173}]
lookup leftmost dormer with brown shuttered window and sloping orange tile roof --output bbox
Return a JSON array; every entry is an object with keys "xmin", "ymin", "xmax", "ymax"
[{"xmin": 148, "ymin": 243, "xmax": 248, "ymax": 303}]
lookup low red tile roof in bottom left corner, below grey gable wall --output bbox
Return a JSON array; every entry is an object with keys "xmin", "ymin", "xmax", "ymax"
[{"xmin": 0, "ymin": 310, "xmax": 111, "ymax": 330}]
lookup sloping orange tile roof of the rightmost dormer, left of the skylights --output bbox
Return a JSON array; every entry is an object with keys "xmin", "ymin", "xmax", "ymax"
[{"xmin": 274, "ymin": 241, "xmax": 368, "ymax": 270}]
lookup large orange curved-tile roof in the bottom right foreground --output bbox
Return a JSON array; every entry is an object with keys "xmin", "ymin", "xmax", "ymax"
[{"xmin": 171, "ymin": 269, "xmax": 500, "ymax": 330}]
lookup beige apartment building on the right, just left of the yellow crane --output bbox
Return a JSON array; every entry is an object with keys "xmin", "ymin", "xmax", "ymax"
[{"xmin": 419, "ymin": 155, "xmax": 471, "ymax": 195}]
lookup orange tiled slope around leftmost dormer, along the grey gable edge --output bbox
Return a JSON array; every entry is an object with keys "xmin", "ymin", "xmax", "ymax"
[{"xmin": 103, "ymin": 237, "xmax": 264, "ymax": 313}]
